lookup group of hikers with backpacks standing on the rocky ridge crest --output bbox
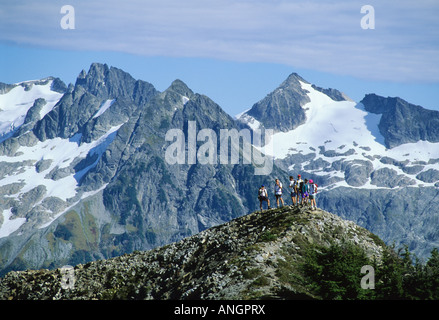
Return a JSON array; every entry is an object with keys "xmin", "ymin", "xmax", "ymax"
[{"xmin": 258, "ymin": 174, "xmax": 318, "ymax": 211}]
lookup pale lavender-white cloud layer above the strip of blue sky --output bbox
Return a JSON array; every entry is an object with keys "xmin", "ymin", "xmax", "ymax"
[{"xmin": 0, "ymin": 0, "xmax": 439, "ymax": 82}]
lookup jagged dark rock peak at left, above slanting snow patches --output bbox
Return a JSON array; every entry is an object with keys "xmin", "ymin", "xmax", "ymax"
[{"xmin": 33, "ymin": 63, "xmax": 157, "ymax": 141}]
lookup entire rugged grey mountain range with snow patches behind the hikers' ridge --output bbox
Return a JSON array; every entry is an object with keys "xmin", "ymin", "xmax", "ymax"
[{"xmin": 0, "ymin": 63, "xmax": 439, "ymax": 274}]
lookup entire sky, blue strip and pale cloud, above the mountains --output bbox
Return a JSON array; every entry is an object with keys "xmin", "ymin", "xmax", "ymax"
[{"xmin": 0, "ymin": 0, "xmax": 439, "ymax": 115}]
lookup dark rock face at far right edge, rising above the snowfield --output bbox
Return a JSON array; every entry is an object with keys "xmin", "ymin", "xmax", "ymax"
[{"xmin": 361, "ymin": 94, "xmax": 439, "ymax": 148}]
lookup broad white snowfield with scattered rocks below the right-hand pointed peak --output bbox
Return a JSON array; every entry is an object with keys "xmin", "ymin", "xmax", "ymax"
[{"xmin": 237, "ymin": 75, "xmax": 439, "ymax": 190}]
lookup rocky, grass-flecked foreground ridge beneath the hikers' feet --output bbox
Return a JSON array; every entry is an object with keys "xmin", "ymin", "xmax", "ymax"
[{"xmin": 0, "ymin": 207, "xmax": 385, "ymax": 300}]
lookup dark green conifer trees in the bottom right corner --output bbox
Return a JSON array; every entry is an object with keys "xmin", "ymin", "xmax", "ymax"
[{"xmin": 301, "ymin": 243, "xmax": 439, "ymax": 300}]
